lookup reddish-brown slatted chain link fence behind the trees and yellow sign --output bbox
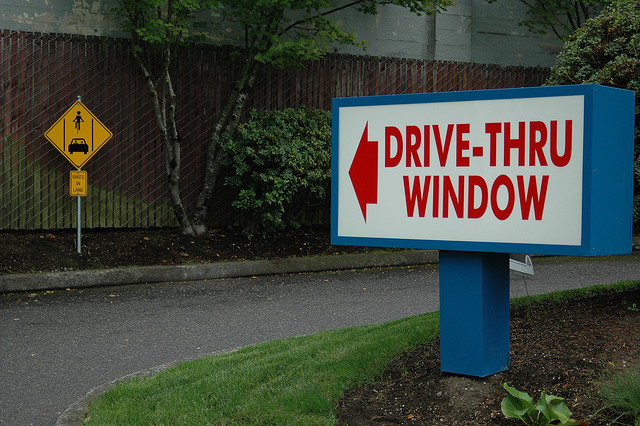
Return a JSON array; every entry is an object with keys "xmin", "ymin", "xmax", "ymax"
[{"xmin": 0, "ymin": 30, "xmax": 548, "ymax": 229}]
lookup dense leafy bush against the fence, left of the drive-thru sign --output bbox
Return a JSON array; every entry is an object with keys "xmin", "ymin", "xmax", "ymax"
[{"xmin": 221, "ymin": 109, "xmax": 331, "ymax": 237}]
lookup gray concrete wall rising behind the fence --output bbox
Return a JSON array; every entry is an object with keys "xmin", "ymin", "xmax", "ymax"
[{"xmin": 0, "ymin": 0, "xmax": 561, "ymax": 67}]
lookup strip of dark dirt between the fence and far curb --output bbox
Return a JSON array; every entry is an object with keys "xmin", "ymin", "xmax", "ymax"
[{"xmin": 0, "ymin": 228, "xmax": 380, "ymax": 274}]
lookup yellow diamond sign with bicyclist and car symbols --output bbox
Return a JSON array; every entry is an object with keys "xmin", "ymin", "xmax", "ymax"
[{"xmin": 44, "ymin": 101, "xmax": 113, "ymax": 169}]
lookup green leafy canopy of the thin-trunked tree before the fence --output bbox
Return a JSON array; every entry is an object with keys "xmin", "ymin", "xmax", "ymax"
[{"xmin": 112, "ymin": 0, "xmax": 452, "ymax": 68}]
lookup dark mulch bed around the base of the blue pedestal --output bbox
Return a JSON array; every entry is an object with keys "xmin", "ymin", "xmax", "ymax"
[{"xmin": 338, "ymin": 290, "xmax": 640, "ymax": 426}]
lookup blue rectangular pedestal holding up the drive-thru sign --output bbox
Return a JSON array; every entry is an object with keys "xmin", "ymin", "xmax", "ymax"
[{"xmin": 440, "ymin": 250, "xmax": 510, "ymax": 377}]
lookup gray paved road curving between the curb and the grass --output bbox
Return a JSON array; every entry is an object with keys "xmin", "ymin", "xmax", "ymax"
[{"xmin": 0, "ymin": 256, "xmax": 640, "ymax": 425}]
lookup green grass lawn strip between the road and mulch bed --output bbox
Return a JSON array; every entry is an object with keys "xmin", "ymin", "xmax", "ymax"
[{"xmin": 87, "ymin": 282, "xmax": 640, "ymax": 425}]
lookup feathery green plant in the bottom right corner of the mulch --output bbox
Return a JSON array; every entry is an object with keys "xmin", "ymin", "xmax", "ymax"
[{"xmin": 599, "ymin": 368, "xmax": 640, "ymax": 426}]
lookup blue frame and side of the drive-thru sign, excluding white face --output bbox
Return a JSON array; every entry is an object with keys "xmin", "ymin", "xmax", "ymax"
[{"xmin": 331, "ymin": 85, "xmax": 635, "ymax": 256}]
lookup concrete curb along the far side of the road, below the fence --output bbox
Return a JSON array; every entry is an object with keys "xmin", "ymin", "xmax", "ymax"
[{"xmin": 0, "ymin": 250, "xmax": 438, "ymax": 294}]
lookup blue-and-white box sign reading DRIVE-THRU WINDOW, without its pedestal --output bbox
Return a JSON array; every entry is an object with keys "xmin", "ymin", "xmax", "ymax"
[{"xmin": 331, "ymin": 85, "xmax": 634, "ymax": 256}]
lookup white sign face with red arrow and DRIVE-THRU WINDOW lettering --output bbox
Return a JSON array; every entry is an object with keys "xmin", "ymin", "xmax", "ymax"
[{"xmin": 332, "ymin": 95, "xmax": 585, "ymax": 246}]
